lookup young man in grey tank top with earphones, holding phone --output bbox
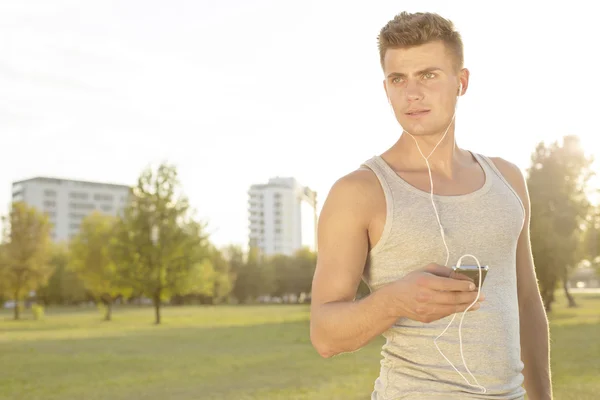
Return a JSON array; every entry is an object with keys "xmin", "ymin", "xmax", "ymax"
[{"xmin": 310, "ymin": 13, "xmax": 552, "ymax": 400}]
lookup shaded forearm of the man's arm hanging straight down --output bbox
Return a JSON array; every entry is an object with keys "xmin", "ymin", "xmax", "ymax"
[{"xmin": 520, "ymin": 298, "xmax": 552, "ymax": 400}]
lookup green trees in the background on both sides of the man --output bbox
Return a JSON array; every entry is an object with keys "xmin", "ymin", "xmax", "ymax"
[{"xmin": 0, "ymin": 136, "xmax": 600, "ymax": 323}]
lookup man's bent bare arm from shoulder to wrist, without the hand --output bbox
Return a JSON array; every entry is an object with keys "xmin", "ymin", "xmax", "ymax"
[{"xmin": 310, "ymin": 171, "xmax": 397, "ymax": 357}]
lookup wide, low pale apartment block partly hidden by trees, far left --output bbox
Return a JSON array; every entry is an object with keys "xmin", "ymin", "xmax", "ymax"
[{"xmin": 12, "ymin": 177, "xmax": 131, "ymax": 241}]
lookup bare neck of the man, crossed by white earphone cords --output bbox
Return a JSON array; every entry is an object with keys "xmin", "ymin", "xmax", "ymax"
[{"xmin": 385, "ymin": 123, "xmax": 466, "ymax": 177}]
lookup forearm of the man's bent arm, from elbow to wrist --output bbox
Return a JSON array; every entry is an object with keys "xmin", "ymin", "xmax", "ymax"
[{"xmin": 310, "ymin": 289, "xmax": 398, "ymax": 357}]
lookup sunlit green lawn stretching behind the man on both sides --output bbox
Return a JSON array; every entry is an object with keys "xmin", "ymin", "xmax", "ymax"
[{"xmin": 0, "ymin": 295, "xmax": 600, "ymax": 400}]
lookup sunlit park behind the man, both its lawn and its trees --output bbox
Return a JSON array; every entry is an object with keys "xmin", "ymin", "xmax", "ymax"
[{"xmin": 0, "ymin": 137, "xmax": 600, "ymax": 400}]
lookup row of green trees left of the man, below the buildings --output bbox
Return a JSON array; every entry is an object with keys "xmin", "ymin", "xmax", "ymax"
[{"xmin": 0, "ymin": 164, "xmax": 316, "ymax": 324}]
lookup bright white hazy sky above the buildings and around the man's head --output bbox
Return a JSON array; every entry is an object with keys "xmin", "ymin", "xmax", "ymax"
[{"xmin": 0, "ymin": 0, "xmax": 600, "ymax": 246}]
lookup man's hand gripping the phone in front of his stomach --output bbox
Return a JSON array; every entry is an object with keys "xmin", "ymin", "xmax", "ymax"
[{"xmin": 384, "ymin": 264, "xmax": 484, "ymax": 323}]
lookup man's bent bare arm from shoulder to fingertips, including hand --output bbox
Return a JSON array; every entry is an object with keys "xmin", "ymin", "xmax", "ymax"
[{"xmin": 310, "ymin": 171, "xmax": 477, "ymax": 357}]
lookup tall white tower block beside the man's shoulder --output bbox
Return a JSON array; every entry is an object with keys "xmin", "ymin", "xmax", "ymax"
[{"xmin": 248, "ymin": 177, "xmax": 317, "ymax": 256}]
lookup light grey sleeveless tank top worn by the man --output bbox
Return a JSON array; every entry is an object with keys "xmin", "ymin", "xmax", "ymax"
[{"xmin": 361, "ymin": 153, "xmax": 525, "ymax": 400}]
